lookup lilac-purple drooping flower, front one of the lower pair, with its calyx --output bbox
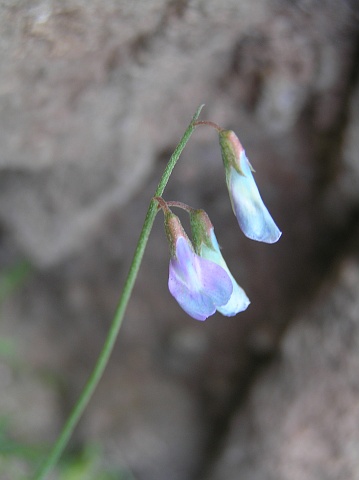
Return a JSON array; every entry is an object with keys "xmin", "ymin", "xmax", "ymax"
[{"xmin": 165, "ymin": 211, "xmax": 233, "ymax": 320}]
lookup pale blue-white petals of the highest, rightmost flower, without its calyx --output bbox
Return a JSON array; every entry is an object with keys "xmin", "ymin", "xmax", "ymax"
[{"xmin": 228, "ymin": 151, "xmax": 282, "ymax": 243}]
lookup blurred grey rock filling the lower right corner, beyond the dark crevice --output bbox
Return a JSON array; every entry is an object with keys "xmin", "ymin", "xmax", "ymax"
[{"xmin": 207, "ymin": 251, "xmax": 359, "ymax": 480}]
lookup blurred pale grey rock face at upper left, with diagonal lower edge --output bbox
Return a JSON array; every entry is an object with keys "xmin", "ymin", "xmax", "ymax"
[{"xmin": 0, "ymin": 0, "xmax": 267, "ymax": 264}]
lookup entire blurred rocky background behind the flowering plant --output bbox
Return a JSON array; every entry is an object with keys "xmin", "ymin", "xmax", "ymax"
[{"xmin": 0, "ymin": 0, "xmax": 359, "ymax": 480}]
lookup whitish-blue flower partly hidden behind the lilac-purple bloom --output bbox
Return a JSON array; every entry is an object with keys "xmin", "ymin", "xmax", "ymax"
[{"xmin": 190, "ymin": 210, "xmax": 250, "ymax": 317}]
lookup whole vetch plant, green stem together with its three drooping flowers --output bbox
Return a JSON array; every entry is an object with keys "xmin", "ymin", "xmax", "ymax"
[{"xmin": 33, "ymin": 105, "xmax": 281, "ymax": 480}]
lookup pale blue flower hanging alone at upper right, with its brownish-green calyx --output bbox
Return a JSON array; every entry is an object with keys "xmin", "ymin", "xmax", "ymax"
[{"xmin": 219, "ymin": 130, "xmax": 282, "ymax": 243}]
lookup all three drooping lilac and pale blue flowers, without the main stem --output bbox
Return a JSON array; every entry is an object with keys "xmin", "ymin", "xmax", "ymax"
[{"xmin": 156, "ymin": 127, "xmax": 281, "ymax": 320}]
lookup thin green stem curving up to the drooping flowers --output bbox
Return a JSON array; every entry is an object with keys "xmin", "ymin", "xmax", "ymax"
[{"xmin": 33, "ymin": 105, "xmax": 203, "ymax": 480}]
